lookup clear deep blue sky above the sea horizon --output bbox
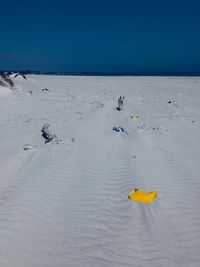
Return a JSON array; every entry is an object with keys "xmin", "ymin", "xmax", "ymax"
[{"xmin": 0, "ymin": 0, "xmax": 200, "ymax": 72}]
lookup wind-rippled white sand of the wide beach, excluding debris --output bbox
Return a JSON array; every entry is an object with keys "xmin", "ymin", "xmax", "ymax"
[{"xmin": 0, "ymin": 75, "xmax": 200, "ymax": 267}]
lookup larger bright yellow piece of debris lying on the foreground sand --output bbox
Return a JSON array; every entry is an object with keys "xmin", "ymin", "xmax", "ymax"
[{"xmin": 128, "ymin": 189, "xmax": 157, "ymax": 204}]
